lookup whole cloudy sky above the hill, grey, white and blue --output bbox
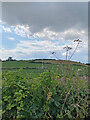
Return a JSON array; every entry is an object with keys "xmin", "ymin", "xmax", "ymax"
[{"xmin": 0, "ymin": 2, "xmax": 88, "ymax": 63}]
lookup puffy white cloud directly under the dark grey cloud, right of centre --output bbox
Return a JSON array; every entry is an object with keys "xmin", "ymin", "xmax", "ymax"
[{"xmin": 33, "ymin": 28, "xmax": 87, "ymax": 42}]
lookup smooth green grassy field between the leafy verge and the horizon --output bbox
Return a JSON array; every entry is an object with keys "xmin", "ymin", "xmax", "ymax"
[{"xmin": 2, "ymin": 60, "xmax": 88, "ymax": 77}]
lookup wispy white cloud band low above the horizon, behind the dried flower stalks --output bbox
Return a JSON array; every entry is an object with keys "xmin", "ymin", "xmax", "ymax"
[{"xmin": 2, "ymin": 36, "xmax": 88, "ymax": 60}]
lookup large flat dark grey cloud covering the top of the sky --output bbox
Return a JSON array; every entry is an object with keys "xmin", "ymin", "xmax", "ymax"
[{"xmin": 2, "ymin": 2, "xmax": 88, "ymax": 33}]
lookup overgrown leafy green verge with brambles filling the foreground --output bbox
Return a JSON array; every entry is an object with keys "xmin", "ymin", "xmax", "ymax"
[{"xmin": 2, "ymin": 70, "xmax": 88, "ymax": 119}]
